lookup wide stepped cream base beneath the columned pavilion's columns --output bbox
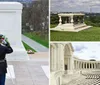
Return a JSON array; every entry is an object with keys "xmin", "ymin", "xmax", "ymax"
[{"xmin": 50, "ymin": 23, "xmax": 92, "ymax": 32}]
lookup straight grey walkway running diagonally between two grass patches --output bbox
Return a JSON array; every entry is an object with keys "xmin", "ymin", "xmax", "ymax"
[{"xmin": 22, "ymin": 35, "xmax": 48, "ymax": 52}]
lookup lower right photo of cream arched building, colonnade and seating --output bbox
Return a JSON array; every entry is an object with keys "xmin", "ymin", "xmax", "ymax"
[{"xmin": 50, "ymin": 42, "xmax": 100, "ymax": 85}]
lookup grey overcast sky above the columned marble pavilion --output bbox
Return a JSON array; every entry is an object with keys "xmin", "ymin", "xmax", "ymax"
[{"xmin": 51, "ymin": 0, "xmax": 100, "ymax": 12}]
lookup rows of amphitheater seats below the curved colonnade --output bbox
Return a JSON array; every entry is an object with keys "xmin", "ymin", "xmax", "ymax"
[{"xmin": 66, "ymin": 72, "xmax": 100, "ymax": 85}]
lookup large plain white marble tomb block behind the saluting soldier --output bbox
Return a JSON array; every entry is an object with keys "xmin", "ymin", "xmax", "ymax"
[{"xmin": 0, "ymin": 2, "xmax": 28, "ymax": 60}]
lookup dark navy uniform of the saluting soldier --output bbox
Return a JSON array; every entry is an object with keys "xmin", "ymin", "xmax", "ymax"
[{"xmin": 0, "ymin": 35, "xmax": 13, "ymax": 85}]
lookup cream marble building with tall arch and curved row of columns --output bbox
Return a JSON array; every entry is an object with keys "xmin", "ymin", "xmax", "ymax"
[{"xmin": 50, "ymin": 43, "xmax": 100, "ymax": 72}]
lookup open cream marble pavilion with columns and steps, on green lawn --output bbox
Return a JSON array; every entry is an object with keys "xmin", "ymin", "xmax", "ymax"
[{"xmin": 51, "ymin": 13, "xmax": 91, "ymax": 32}]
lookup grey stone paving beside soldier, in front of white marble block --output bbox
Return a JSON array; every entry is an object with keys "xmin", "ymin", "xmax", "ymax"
[{"xmin": 6, "ymin": 53, "xmax": 49, "ymax": 85}]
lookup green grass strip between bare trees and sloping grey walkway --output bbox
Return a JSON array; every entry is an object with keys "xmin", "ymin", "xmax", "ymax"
[{"xmin": 24, "ymin": 33, "xmax": 49, "ymax": 48}]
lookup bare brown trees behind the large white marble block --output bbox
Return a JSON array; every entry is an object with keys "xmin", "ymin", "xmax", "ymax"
[{"xmin": 23, "ymin": 0, "xmax": 49, "ymax": 38}]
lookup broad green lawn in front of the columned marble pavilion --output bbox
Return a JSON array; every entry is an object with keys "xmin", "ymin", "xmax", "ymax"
[{"xmin": 50, "ymin": 27, "xmax": 100, "ymax": 41}]
